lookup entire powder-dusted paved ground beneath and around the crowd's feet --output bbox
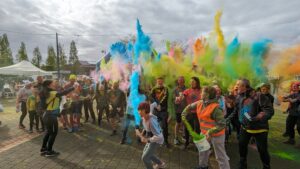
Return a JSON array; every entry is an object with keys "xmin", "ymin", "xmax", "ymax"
[{"xmin": 0, "ymin": 98, "xmax": 300, "ymax": 169}]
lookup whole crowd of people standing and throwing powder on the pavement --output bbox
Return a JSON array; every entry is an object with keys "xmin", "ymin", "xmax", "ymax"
[{"xmin": 16, "ymin": 75, "xmax": 300, "ymax": 169}]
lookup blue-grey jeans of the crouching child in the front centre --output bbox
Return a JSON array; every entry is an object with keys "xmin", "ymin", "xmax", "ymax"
[{"xmin": 142, "ymin": 143, "xmax": 162, "ymax": 169}]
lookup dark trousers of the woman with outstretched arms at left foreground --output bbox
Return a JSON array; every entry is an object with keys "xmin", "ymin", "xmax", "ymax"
[{"xmin": 42, "ymin": 112, "xmax": 58, "ymax": 151}]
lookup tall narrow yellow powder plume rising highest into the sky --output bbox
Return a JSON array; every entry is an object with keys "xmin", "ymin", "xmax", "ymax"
[{"xmin": 214, "ymin": 11, "xmax": 225, "ymax": 57}]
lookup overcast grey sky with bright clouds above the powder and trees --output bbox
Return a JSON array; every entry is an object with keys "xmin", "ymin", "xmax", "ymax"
[{"xmin": 0, "ymin": 0, "xmax": 300, "ymax": 61}]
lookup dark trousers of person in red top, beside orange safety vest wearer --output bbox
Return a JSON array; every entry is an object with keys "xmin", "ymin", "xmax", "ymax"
[{"xmin": 184, "ymin": 113, "xmax": 200, "ymax": 146}]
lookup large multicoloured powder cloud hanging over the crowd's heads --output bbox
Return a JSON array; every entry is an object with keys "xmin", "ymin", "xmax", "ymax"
[{"xmin": 97, "ymin": 11, "xmax": 278, "ymax": 104}]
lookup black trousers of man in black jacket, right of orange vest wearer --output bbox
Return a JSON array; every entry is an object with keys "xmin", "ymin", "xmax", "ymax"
[{"xmin": 239, "ymin": 129, "xmax": 270, "ymax": 169}]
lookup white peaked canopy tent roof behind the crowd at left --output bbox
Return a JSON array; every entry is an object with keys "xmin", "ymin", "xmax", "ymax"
[{"xmin": 0, "ymin": 60, "xmax": 52, "ymax": 76}]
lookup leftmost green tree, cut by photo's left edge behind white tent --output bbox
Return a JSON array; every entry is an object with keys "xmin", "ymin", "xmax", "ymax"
[{"xmin": 0, "ymin": 34, "xmax": 14, "ymax": 67}]
